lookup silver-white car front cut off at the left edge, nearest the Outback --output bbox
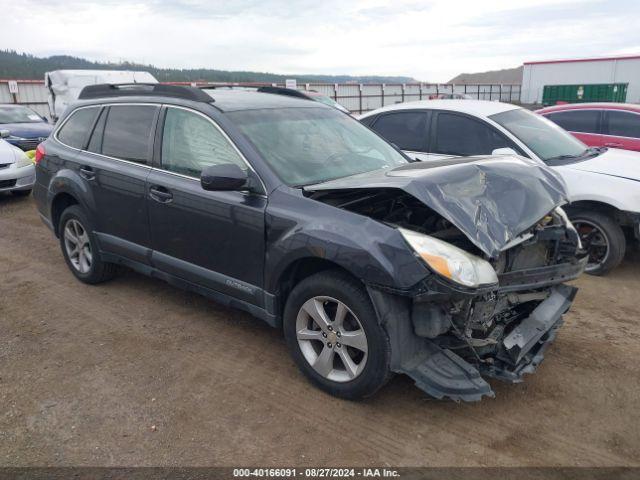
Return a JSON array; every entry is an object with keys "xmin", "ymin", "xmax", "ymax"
[{"xmin": 0, "ymin": 136, "xmax": 36, "ymax": 196}]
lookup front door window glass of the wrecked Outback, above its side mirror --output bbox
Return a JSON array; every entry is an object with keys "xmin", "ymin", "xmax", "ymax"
[{"xmin": 162, "ymin": 108, "xmax": 247, "ymax": 177}]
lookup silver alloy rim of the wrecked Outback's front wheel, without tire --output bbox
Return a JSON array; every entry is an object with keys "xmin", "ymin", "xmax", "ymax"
[{"xmin": 296, "ymin": 296, "xmax": 368, "ymax": 382}]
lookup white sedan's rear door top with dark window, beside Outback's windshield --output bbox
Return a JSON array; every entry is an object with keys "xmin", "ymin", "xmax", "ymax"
[{"xmin": 370, "ymin": 110, "xmax": 431, "ymax": 160}]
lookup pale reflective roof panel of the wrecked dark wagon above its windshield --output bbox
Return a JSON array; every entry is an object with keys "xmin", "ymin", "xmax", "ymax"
[{"xmin": 203, "ymin": 89, "xmax": 322, "ymax": 112}]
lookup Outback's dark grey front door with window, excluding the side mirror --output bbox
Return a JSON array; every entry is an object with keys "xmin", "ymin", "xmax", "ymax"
[{"xmin": 147, "ymin": 106, "xmax": 267, "ymax": 307}]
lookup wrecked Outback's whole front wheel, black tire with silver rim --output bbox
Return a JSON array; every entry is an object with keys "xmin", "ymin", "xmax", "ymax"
[{"xmin": 284, "ymin": 271, "xmax": 391, "ymax": 400}]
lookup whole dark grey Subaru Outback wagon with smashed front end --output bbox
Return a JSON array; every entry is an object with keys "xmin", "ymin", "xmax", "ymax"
[{"xmin": 34, "ymin": 85, "xmax": 587, "ymax": 400}]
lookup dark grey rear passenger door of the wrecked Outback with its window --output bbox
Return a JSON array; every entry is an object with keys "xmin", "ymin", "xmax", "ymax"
[{"xmin": 58, "ymin": 104, "xmax": 160, "ymax": 262}]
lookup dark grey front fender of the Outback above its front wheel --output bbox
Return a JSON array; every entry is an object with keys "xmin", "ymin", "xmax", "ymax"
[{"xmin": 265, "ymin": 191, "xmax": 429, "ymax": 292}]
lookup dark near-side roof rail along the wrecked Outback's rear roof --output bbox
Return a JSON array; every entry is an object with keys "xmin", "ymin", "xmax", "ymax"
[{"xmin": 78, "ymin": 83, "xmax": 214, "ymax": 103}]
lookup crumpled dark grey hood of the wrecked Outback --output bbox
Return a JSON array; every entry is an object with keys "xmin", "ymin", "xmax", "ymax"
[{"xmin": 305, "ymin": 155, "xmax": 568, "ymax": 257}]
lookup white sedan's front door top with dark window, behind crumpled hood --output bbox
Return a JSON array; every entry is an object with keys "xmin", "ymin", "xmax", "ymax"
[{"xmin": 427, "ymin": 111, "xmax": 525, "ymax": 161}]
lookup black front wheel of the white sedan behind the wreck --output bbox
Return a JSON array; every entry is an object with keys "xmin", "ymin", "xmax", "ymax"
[{"xmin": 570, "ymin": 210, "xmax": 627, "ymax": 275}]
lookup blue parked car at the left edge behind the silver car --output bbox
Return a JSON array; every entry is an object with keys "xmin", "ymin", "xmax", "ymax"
[{"xmin": 0, "ymin": 104, "xmax": 52, "ymax": 151}]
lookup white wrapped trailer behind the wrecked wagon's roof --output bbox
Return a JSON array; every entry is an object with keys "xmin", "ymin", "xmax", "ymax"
[{"xmin": 44, "ymin": 70, "xmax": 158, "ymax": 122}]
